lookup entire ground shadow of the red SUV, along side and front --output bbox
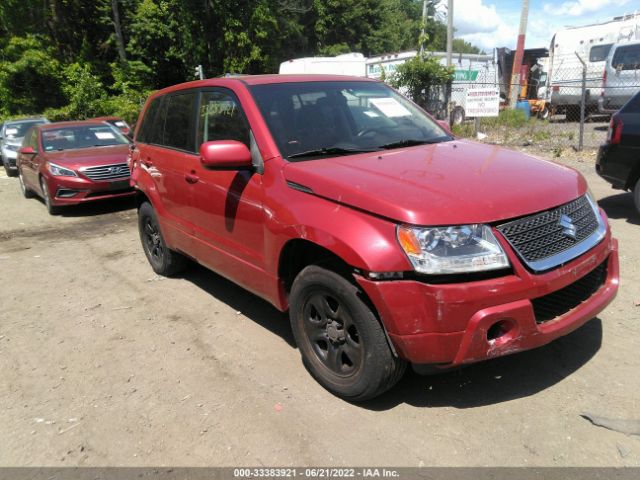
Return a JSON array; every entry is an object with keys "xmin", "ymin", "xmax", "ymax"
[{"xmin": 182, "ymin": 258, "xmax": 602, "ymax": 411}]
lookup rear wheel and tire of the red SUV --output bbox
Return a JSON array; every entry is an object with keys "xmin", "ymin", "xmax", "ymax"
[{"xmin": 138, "ymin": 202, "xmax": 187, "ymax": 277}]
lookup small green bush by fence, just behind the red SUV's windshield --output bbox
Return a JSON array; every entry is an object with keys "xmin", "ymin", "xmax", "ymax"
[{"xmin": 390, "ymin": 56, "xmax": 453, "ymax": 100}]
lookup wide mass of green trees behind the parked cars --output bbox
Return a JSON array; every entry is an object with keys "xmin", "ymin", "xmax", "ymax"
[{"xmin": 0, "ymin": 0, "xmax": 477, "ymax": 121}]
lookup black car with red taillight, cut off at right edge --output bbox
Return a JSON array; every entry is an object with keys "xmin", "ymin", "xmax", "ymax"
[{"xmin": 596, "ymin": 92, "xmax": 640, "ymax": 212}]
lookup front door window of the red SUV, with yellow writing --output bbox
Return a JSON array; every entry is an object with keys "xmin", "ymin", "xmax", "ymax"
[{"xmin": 198, "ymin": 91, "xmax": 249, "ymax": 147}]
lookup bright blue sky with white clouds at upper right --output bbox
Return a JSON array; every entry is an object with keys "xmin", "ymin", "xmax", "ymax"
[{"xmin": 452, "ymin": 0, "xmax": 640, "ymax": 53}]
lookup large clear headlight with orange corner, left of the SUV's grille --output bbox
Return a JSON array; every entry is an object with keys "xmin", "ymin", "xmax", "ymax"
[{"xmin": 397, "ymin": 225, "xmax": 509, "ymax": 275}]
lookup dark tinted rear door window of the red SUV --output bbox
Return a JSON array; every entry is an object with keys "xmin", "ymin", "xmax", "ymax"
[{"xmin": 161, "ymin": 92, "xmax": 197, "ymax": 152}]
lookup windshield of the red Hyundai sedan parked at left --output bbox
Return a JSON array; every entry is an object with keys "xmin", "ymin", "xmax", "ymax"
[{"xmin": 42, "ymin": 125, "xmax": 129, "ymax": 152}]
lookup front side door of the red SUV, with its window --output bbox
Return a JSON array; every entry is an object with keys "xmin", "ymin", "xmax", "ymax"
[{"xmin": 190, "ymin": 88, "xmax": 267, "ymax": 293}]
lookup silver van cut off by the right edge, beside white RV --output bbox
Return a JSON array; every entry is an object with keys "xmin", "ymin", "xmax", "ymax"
[{"xmin": 598, "ymin": 40, "xmax": 640, "ymax": 113}]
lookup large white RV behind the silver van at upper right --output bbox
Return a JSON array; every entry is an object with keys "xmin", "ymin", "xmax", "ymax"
[{"xmin": 548, "ymin": 14, "xmax": 640, "ymax": 119}]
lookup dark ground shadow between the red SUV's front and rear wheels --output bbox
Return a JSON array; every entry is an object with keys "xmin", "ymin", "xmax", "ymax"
[{"xmin": 182, "ymin": 264, "xmax": 296, "ymax": 346}]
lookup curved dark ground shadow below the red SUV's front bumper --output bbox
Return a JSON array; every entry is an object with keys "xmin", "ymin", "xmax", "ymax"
[{"xmin": 362, "ymin": 318, "xmax": 602, "ymax": 411}]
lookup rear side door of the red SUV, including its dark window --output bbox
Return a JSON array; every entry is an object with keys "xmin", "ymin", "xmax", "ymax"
[{"xmin": 136, "ymin": 90, "xmax": 198, "ymax": 253}]
